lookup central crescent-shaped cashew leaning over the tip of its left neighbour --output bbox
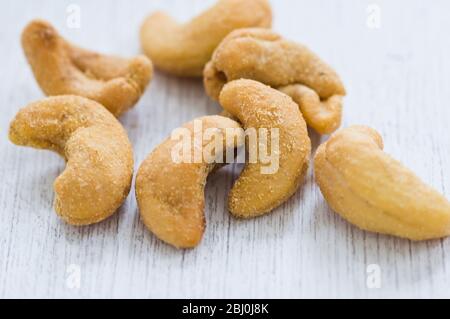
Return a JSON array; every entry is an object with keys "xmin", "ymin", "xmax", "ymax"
[{"xmin": 220, "ymin": 80, "xmax": 311, "ymax": 218}]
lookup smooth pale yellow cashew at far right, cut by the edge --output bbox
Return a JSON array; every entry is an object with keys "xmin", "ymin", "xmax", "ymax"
[{"xmin": 315, "ymin": 126, "xmax": 450, "ymax": 240}]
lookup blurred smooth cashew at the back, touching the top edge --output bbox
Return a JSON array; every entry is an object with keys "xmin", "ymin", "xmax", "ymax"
[{"xmin": 141, "ymin": 0, "xmax": 272, "ymax": 77}]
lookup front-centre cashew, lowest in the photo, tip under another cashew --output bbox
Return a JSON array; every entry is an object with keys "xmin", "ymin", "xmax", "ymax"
[{"xmin": 136, "ymin": 116, "xmax": 244, "ymax": 248}]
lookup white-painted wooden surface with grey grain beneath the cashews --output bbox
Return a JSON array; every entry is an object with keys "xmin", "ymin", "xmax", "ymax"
[{"xmin": 0, "ymin": 0, "xmax": 450, "ymax": 298}]
